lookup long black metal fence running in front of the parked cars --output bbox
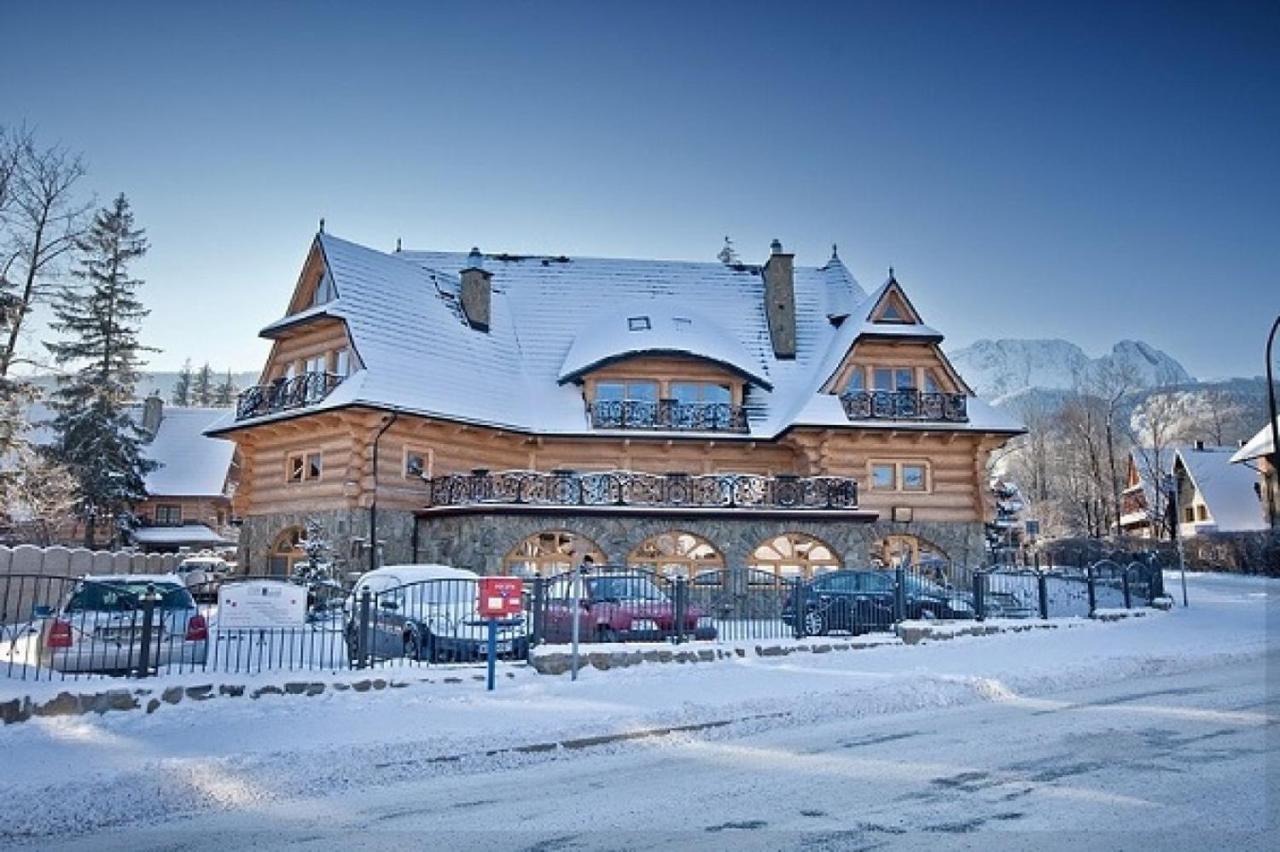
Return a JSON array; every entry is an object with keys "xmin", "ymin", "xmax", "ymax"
[{"xmin": 0, "ymin": 560, "xmax": 1164, "ymax": 681}]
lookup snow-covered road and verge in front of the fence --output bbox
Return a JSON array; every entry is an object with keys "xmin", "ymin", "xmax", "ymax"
[{"xmin": 0, "ymin": 576, "xmax": 1280, "ymax": 848}]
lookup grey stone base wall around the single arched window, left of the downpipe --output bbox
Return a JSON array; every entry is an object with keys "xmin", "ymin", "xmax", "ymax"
[{"xmin": 237, "ymin": 509, "xmax": 413, "ymax": 574}]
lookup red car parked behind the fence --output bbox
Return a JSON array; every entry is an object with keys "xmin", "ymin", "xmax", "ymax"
[{"xmin": 543, "ymin": 573, "xmax": 716, "ymax": 642}]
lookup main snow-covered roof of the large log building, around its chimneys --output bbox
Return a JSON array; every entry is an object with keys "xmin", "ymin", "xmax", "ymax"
[{"xmin": 215, "ymin": 234, "xmax": 1021, "ymax": 439}]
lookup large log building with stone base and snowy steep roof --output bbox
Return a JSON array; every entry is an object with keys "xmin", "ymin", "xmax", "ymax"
[{"xmin": 209, "ymin": 233, "xmax": 1024, "ymax": 580}]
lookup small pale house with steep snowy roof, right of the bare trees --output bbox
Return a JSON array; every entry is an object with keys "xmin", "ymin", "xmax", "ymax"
[{"xmin": 1174, "ymin": 443, "xmax": 1267, "ymax": 539}]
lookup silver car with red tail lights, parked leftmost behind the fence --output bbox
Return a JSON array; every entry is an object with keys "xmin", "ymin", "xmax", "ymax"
[{"xmin": 19, "ymin": 574, "xmax": 209, "ymax": 673}]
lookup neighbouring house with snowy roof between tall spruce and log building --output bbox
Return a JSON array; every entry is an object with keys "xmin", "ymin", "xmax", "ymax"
[{"xmin": 133, "ymin": 397, "xmax": 236, "ymax": 551}]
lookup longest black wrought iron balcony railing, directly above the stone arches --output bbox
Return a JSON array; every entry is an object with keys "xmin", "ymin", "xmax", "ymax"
[{"xmin": 430, "ymin": 469, "xmax": 858, "ymax": 509}]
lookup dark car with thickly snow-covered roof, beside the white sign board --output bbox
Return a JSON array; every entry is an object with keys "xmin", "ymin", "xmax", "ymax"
[{"xmin": 343, "ymin": 565, "xmax": 529, "ymax": 663}]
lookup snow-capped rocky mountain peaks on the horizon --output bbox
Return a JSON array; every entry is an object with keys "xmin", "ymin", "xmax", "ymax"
[{"xmin": 951, "ymin": 340, "xmax": 1196, "ymax": 402}]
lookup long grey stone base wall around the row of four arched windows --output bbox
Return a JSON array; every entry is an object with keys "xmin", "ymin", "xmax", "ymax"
[{"xmin": 414, "ymin": 513, "xmax": 986, "ymax": 574}]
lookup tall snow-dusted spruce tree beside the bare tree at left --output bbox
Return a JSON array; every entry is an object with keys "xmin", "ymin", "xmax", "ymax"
[{"xmin": 45, "ymin": 193, "xmax": 156, "ymax": 546}]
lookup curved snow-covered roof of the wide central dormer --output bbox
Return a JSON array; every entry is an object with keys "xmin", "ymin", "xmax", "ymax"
[{"xmin": 559, "ymin": 299, "xmax": 773, "ymax": 388}]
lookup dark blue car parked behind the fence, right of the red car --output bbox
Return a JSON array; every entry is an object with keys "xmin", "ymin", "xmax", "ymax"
[{"xmin": 782, "ymin": 571, "xmax": 973, "ymax": 636}]
